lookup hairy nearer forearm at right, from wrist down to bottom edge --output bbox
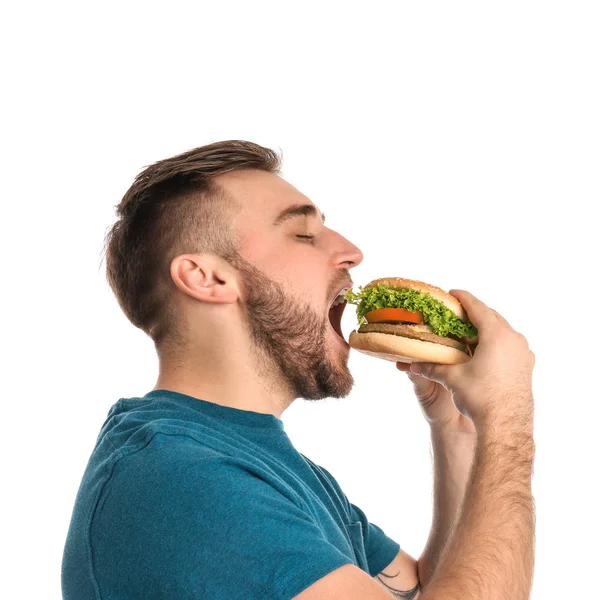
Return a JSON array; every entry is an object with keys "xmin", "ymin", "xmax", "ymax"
[{"xmin": 422, "ymin": 422, "xmax": 535, "ymax": 600}]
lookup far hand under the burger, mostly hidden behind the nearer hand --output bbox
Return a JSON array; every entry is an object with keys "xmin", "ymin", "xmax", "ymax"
[{"xmin": 396, "ymin": 362, "xmax": 475, "ymax": 434}]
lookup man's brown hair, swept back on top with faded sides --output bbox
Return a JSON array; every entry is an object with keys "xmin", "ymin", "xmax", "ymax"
[{"xmin": 104, "ymin": 140, "xmax": 283, "ymax": 358}]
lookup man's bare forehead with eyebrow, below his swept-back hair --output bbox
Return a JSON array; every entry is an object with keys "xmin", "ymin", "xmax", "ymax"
[{"xmin": 215, "ymin": 169, "xmax": 324, "ymax": 232}]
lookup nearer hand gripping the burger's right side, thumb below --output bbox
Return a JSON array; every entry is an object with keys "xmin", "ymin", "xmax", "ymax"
[{"xmin": 410, "ymin": 290, "xmax": 535, "ymax": 434}]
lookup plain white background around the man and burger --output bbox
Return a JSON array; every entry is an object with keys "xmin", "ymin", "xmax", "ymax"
[{"xmin": 0, "ymin": 0, "xmax": 600, "ymax": 600}]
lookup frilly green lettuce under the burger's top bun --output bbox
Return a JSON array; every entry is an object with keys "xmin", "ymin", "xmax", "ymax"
[{"xmin": 345, "ymin": 284, "xmax": 478, "ymax": 338}]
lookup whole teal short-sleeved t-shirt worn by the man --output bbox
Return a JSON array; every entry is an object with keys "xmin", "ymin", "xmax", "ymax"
[{"xmin": 62, "ymin": 390, "xmax": 400, "ymax": 600}]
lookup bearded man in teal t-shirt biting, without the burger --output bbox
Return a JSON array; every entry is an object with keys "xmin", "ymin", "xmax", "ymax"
[{"xmin": 62, "ymin": 141, "xmax": 534, "ymax": 600}]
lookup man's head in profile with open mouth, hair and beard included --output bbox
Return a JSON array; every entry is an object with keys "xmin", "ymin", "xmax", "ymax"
[{"xmin": 105, "ymin": 141, "xmax": 362, "ymax": 399}]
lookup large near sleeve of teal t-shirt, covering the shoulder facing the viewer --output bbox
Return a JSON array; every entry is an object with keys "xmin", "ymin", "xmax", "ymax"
[{"xmin": 90, "ymin": 449, "xmax": 352, "ymax": 600}]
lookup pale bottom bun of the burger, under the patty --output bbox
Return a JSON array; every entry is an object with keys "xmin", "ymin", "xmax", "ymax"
[{"xmin": 348, "ymin": 330, "xmax": 471, "ymax": 365}]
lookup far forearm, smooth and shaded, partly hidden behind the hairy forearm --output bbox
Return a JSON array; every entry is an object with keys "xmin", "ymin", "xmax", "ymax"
[{"xmin": 418, "ymin": 428, "xmax": 476, "ymax": 587}]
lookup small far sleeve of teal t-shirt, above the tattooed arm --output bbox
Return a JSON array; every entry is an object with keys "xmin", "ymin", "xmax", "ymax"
[{"xmin": 319, "ymin": 466, "xmax": 400, "ymax": 577}]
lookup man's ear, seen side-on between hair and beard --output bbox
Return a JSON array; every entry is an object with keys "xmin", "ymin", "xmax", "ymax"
[{"xmin": 170, "ymin": 254, "xmax": 239, "ymax": 304}]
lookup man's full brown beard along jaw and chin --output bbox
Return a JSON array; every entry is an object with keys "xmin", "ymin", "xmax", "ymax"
[{"xmin": 227, "ymin": 254, "xmax": 354, "ymax": 400}]
